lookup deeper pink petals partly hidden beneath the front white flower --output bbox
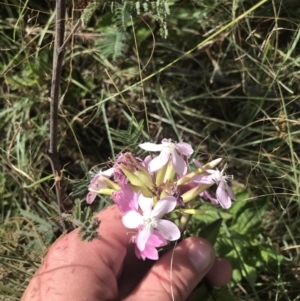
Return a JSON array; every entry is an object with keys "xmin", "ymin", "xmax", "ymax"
[{"xmin": 132, "ymin": 230, "xmax": 167, "ymax": 260}]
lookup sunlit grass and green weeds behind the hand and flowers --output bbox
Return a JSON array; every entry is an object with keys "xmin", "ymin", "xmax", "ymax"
[{"xmin": 0, "ymin": 0, "xmax": 300, "ymax": 300}]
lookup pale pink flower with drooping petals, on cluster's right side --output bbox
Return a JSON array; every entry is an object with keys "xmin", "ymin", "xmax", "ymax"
[{"xmin": 193, "ymin": 166, "xmax": 235, "ymax": 209}]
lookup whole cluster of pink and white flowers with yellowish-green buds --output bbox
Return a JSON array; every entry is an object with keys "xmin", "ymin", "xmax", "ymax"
[{"xmin": 86, "ymin": 139, "xmax": 235, "ymax": 260}]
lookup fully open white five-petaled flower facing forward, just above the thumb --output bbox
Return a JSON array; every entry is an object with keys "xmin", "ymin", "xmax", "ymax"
[{"xmin": 122, "ymin": 193, "xmax": 180, "ymax": 252}]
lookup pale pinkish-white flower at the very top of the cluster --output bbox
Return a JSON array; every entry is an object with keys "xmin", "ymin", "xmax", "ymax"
[{"xmin": 139, "ymin": 139, "xmax": 194, "ymax": 176}]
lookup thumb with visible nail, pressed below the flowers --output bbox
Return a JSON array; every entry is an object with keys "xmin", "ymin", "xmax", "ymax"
[{"xmin": 124, "ymin": 237, "xmax": 215, "ymax": 301}]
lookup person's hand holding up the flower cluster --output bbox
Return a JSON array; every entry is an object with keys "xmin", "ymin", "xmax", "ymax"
[{"xmin": 21, "ymin": 206, "xmax": 232, "ymax": 301}]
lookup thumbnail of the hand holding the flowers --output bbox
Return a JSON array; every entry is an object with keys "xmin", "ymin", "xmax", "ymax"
[{"xmin": 187, "ymin": 241, "xmax": 214, "ymax": 273}]
